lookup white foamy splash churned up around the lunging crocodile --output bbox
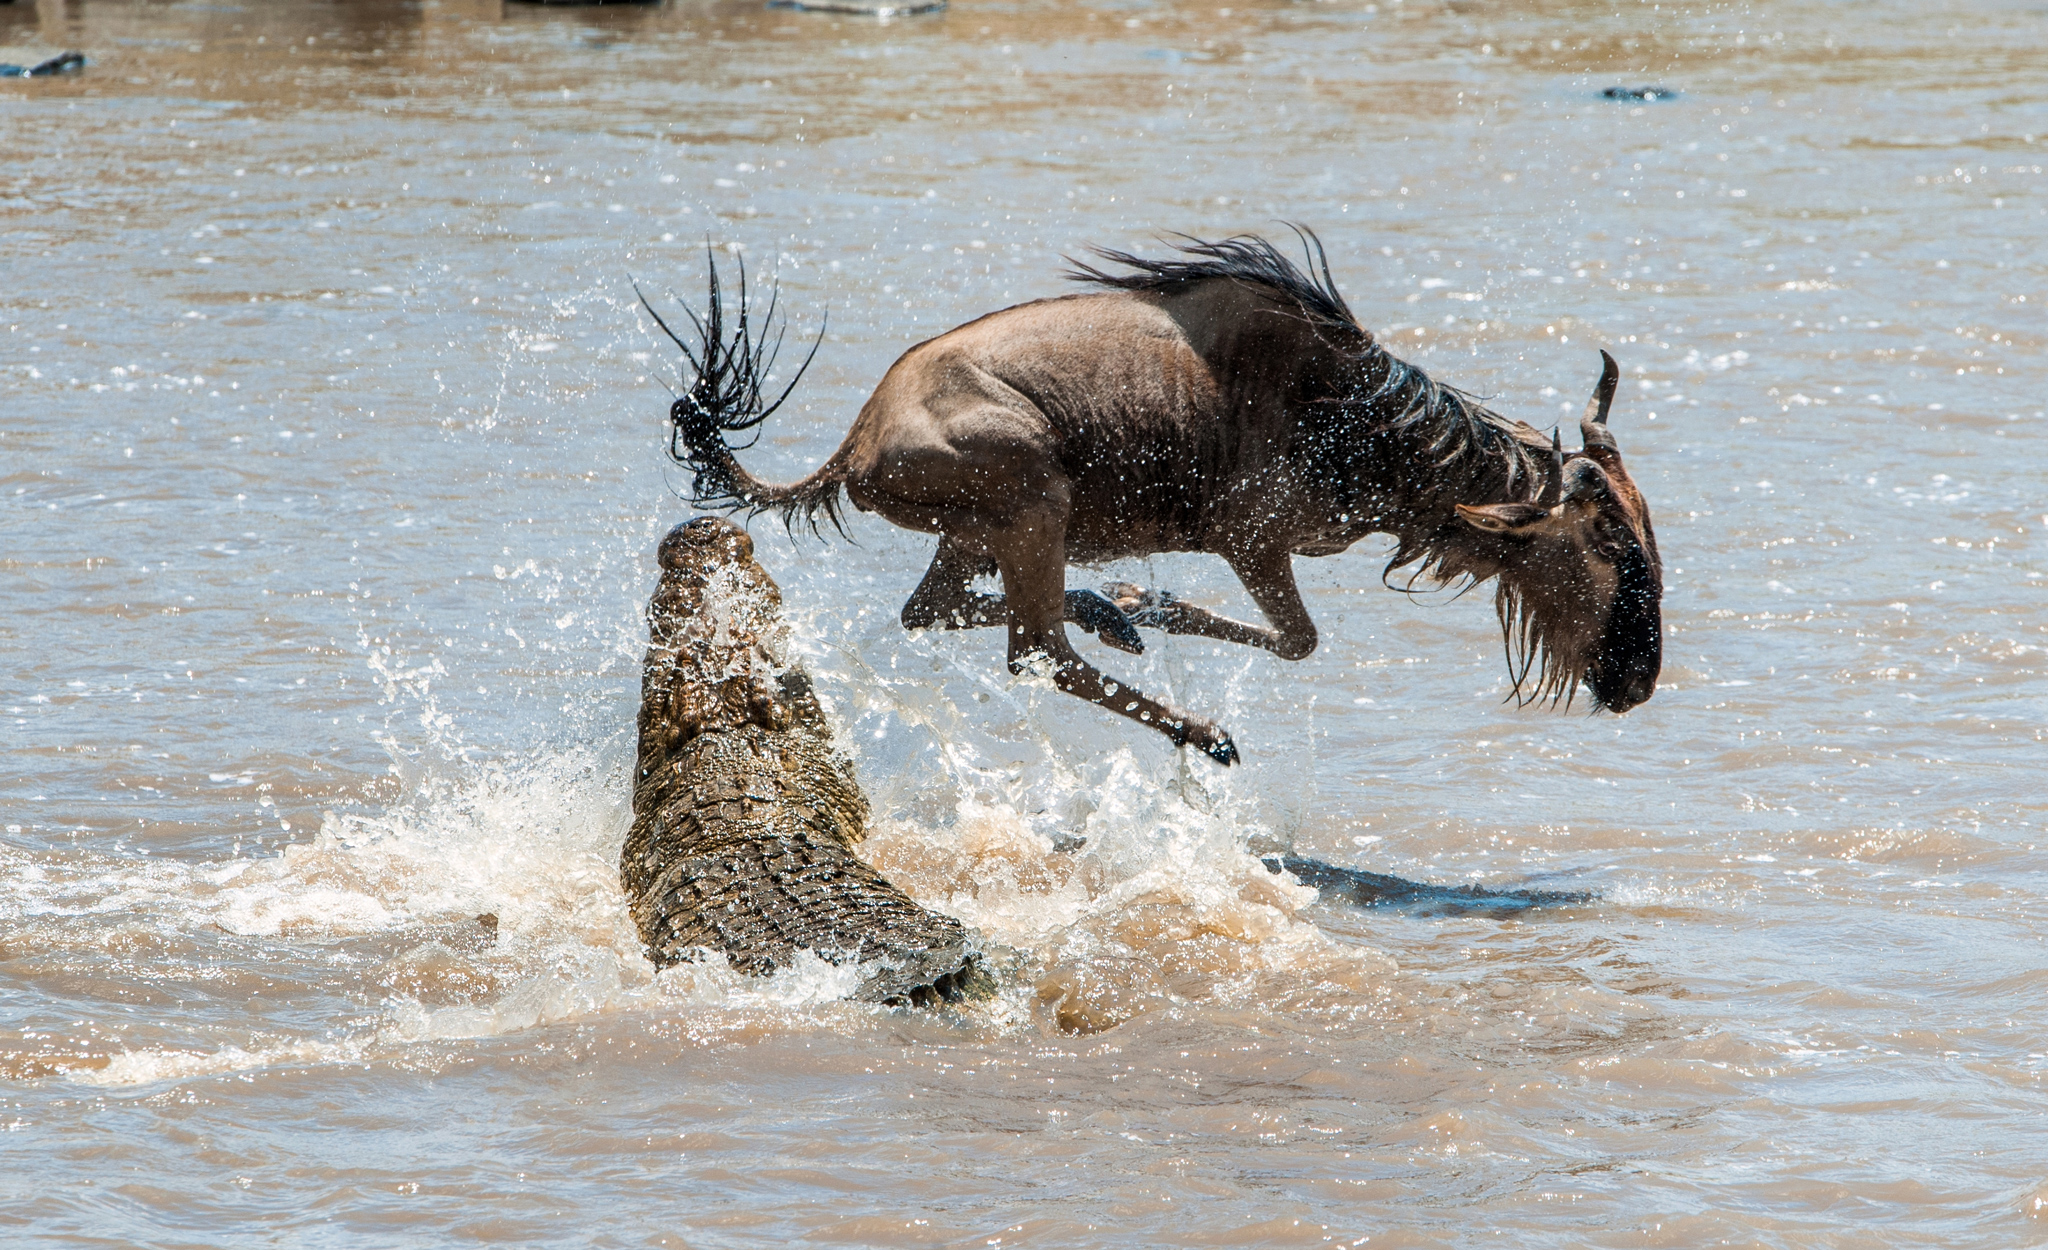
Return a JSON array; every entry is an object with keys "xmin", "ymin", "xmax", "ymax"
[{"xmin": 19, "ymin": 627, "xmax": 1391, "ymax": 1086}]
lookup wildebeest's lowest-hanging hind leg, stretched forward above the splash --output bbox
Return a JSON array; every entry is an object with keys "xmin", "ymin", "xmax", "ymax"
[{"xmin": 989, "ymin": 514, "xmax": 1237, "ymax": 764}]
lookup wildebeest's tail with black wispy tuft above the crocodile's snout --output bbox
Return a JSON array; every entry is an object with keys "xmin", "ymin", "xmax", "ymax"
[{"xmin": 635, "ymin": 248, "xmax": 846, "ymax": 533}]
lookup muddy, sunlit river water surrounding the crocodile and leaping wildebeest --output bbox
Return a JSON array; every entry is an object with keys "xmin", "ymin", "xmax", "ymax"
[{"xmin": 0, "ymin": 0, "xmax": 2048, "ymax": 1248}]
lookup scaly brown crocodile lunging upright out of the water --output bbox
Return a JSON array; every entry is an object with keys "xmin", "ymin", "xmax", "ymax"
[{"xmin": 618, "ymin": 516, "xmax": 977, "ymax": 1004}]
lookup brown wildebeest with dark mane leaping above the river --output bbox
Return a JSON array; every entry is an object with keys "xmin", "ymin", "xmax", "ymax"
[{"xmin": 647, "ymin": 227, "xmax": 1663, "ymax": 764}]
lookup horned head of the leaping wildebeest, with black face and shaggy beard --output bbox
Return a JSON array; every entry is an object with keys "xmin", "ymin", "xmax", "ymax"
[{"xmin": 1458, "ymin": 352, "xmax": 1663, "ymax": 711}]
